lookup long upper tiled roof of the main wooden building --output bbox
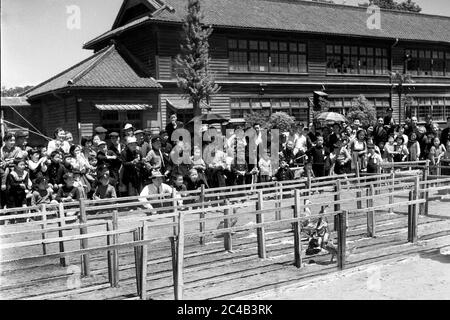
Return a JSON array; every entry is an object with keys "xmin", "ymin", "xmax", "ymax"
[{"xmin": 85, "ymin": 0, "xmax": 450, "ymax": 48}]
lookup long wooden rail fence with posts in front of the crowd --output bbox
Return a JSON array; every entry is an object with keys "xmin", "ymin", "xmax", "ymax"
[{"xmin": 0, "ymin": 169, "xmax": 450, "ymax": 299}]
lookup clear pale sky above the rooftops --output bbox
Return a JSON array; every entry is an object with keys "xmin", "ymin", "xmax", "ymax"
[{"xmin": 1, "ymin": 0, "xmax": 450, "ymax": 88}]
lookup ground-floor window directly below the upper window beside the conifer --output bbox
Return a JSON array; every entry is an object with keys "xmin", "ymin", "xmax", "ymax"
[{"xmin": 230, "ymin": 98, "xmax": 309, "ymax": 122}]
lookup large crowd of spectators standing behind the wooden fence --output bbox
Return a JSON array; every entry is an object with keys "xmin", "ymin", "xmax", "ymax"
[{"xmin": 0, "ymin": 110, "xmax": 450, "ymax": 208}]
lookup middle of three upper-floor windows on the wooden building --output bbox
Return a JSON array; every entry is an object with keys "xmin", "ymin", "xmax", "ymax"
[{"xmin": 326, "ymin": 45, "xmax": 389, "ymax": 75}]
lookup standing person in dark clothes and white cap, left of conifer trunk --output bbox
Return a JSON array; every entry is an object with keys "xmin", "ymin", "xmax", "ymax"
[{"xmin": 121, "ymin": 137, "xmax": 141, "ymax": 197}]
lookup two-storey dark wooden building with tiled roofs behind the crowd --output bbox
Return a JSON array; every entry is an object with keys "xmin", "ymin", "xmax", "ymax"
[{"xmin": 20, "ymin": 0, "xmax": 450, "ymax": 139}]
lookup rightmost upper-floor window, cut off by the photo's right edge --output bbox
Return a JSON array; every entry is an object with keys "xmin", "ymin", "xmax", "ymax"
[{"xmin": 406, "ymin": 49, "xmax": 450, "ymax": 77}]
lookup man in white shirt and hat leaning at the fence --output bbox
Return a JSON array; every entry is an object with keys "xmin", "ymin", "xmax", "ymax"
[{"xmin": 139, "ymin": 171, "xmax": 183, "ymax": 209}]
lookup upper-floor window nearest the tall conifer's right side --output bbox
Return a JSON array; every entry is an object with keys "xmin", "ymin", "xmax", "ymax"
[{"xmin": 228, "ymin": 39, "xmax": 307, "ymax": 73}]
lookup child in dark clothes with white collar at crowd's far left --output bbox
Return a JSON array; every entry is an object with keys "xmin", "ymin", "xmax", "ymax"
[{"xmin": 6, "ymin": 158, "xmax": 32, "ymax": 208}]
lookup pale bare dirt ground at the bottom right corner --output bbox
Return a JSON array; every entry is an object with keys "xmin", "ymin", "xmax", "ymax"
[{"xmin": 239, "ymin": 247, "xmax": 450, "ymax": 300}]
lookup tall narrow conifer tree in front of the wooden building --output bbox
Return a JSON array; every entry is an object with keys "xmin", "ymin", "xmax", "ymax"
[{"xmin": 175, "ymin": 0, "xmax": 220, "ymax": 116}]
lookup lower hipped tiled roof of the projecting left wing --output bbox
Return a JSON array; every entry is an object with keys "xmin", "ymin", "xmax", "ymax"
[{"xmin": 24, "ymin": 45, "xmax": 161, "ymax": 98}]
